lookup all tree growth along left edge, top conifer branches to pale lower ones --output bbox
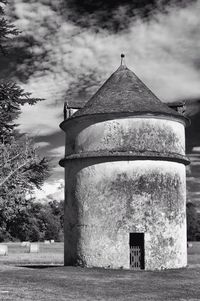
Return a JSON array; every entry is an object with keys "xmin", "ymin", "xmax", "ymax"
[{"xmin": 0, "ymin": 0, "xmax": 49, "ymax": 240}]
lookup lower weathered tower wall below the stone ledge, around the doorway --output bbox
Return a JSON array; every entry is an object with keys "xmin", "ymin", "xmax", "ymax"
[{"xmin": 65, "ymin": 159, "xmax": 187, "ymax": 270}]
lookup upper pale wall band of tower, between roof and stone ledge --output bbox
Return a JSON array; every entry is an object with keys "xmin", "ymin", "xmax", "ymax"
[{"xmin": 66, "ymin": 117, "xmax": 185, "ymax": 155}]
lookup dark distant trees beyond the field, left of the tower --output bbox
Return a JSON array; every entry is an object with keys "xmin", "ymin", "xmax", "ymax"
[{"xmin": 0, "ymin": 200, "xmax": 64, "ymax": 241}]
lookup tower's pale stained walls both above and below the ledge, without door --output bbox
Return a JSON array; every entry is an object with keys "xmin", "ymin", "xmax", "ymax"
[{"xmin": 64, "ymin": 116, "xmax": 187, "ymax": 270}]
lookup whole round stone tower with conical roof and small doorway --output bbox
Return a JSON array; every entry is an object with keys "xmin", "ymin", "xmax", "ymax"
[{"xmin": 60, "ymin": 55, "xmax": 189, "ymax": 270}]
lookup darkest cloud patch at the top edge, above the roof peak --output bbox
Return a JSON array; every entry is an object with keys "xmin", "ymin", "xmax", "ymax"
[{"xmin": 63, "ymin": 0, "xmax": 195, "ymax": 33}]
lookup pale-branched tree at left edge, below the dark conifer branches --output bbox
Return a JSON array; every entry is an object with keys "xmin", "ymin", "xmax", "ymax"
[{"xmin": 0, "ymin": 136, "xmax": 48, "ymax": 238}]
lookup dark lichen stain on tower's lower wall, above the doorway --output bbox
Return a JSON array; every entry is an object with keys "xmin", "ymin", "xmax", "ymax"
[{"xmin": 108, "ymin": 172, "xmax": 183, "ymax": 218}]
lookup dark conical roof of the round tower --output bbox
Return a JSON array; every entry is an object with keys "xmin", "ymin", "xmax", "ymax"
[{"xmin": 70, "ymin": 58, "xmax": 184, "ymax": 119}]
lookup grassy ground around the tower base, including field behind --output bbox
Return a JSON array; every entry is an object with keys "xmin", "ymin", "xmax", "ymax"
[{"xmin": 0, "ymin": 243, "xmax": 200, "ymax": 301}]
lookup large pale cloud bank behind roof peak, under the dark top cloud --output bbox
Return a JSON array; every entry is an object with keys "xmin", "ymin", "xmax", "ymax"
[{"xmin": 8, "ymin": 0, "xmax": 200, "ymax": 114}]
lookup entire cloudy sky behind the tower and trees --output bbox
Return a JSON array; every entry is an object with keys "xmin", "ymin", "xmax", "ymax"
[{"xmin": 0, "ymin": 0, "xmax": 200, "ymax": 202}]
